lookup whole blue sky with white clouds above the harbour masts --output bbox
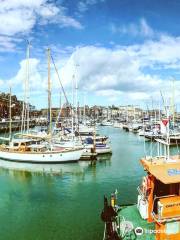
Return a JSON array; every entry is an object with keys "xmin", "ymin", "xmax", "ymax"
[{"xmin": 0, "ymin": 0, "xmax": 180, "ymax": 108}]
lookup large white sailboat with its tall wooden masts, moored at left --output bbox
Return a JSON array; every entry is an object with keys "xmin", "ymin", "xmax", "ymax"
[{"xmin": 0, "ymin": 46, "xmax": 83, "ymax": 163}]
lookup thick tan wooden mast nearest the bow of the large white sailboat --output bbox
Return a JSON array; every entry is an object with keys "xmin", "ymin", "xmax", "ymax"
[{"xmin": 47, "ymin": 48, "xmax": 52, "ymax": 136}]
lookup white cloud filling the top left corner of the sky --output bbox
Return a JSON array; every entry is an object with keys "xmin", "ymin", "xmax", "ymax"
[{"xmin": 0, "ymin": 0, "xmax": 82, "ymax": 51}]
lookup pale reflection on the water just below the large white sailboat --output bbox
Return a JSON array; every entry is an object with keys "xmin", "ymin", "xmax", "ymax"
[{"xmin": 0, "ymin": 155, "xmax": 111, "ymax": 179}]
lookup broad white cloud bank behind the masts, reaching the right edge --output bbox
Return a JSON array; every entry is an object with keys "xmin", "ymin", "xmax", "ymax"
[{"xmin": 2, "ymin": 33, "xmax": 180, "ymax": 106}]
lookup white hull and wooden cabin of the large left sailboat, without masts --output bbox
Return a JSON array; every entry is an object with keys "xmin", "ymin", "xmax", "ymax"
[{"xmin": 0, "ymin": 139, "xmax": 83, "ymax": 163}]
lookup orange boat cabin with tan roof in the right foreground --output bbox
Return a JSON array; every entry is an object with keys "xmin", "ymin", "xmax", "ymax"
[{"xmin": 137, "ymin": 156, "xmax": 180, "ymax": 240}]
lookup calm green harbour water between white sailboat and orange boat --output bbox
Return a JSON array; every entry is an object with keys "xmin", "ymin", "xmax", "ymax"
[{"xmin": 0, "ymin": 127, "xmax": 154, "ymax": 240}]
